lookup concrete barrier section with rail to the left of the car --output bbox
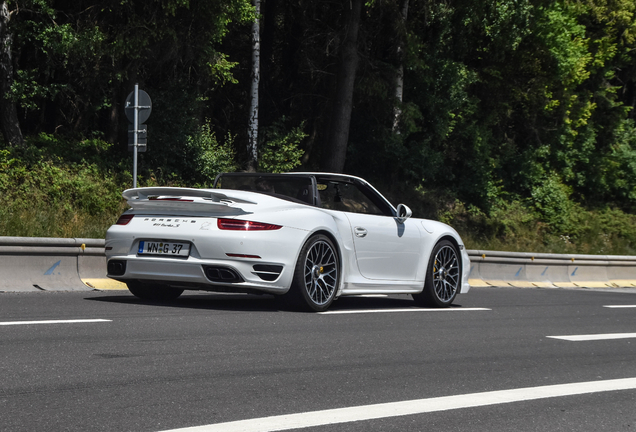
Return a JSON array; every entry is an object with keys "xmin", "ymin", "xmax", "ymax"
[{"xmin": 0, "ymin": 237, "xmax": 126, "ymax": 292}]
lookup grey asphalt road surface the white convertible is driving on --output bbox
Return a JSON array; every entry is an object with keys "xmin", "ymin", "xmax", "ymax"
[{"xmin": 0, "ymin": 288, "xmax": 636, "ymax": 432}]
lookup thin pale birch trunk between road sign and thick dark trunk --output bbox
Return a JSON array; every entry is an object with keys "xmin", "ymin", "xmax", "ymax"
[{"xmin": 247, "ymin": 0, "xmax": 261, "ymax": 172}]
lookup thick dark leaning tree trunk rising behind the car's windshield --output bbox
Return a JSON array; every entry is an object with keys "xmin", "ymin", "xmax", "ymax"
[{"xmin": 323, "ymin": 0, "xmax": 362, "ymax": 173}]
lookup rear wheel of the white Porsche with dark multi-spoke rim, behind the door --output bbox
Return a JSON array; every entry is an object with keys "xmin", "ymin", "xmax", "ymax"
[{"xmin": 282, "ymin": 234, "xmax": 340, "ymax": 312}]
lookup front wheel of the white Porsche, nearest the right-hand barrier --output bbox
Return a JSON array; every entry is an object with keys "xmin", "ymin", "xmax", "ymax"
[{"xmin": 413, "ymin": 240, "xmax": 462, "ymax": 308}]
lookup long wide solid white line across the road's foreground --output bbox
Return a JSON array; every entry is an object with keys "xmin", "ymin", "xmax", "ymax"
[{"xmin": 158, "ymin": 378, "xmax": 636, "ymax": 432}]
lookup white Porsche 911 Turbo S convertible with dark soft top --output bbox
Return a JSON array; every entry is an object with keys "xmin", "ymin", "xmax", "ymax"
[{"xmin": 106, "ymin": 173, "xmax": 470, "ymax": 311}]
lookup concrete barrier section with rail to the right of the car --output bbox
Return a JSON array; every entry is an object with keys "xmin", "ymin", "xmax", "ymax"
[{"xmin": 468, "ymin": 250, "xmax": 636, "ymax": 288}]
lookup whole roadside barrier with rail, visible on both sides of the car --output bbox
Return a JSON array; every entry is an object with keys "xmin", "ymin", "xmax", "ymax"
[{"xmin": 0, "ymin": 236, "xmax": 636, "ymax": 291}]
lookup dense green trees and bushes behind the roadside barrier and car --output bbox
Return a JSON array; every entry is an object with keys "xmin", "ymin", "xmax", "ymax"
[{"xmin": 0, "ymin": 0, "xmax": 636, "ymax": 253}]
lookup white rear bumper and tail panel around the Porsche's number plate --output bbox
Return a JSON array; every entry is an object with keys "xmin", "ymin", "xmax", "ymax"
[{"xmin": 105, "ymin": 216, "xmax": 307, "ymax": 294}]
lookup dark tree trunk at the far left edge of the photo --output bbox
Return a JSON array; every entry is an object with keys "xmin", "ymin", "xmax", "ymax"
[{"xmin": 0, "ymin": 1, "xmax": 24, "ymax": 147}]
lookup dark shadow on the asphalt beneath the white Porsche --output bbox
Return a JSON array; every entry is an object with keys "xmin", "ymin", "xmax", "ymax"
[{"xmin": 85, "ymin": 291, "xmax": 461, "ymax": 313}]
